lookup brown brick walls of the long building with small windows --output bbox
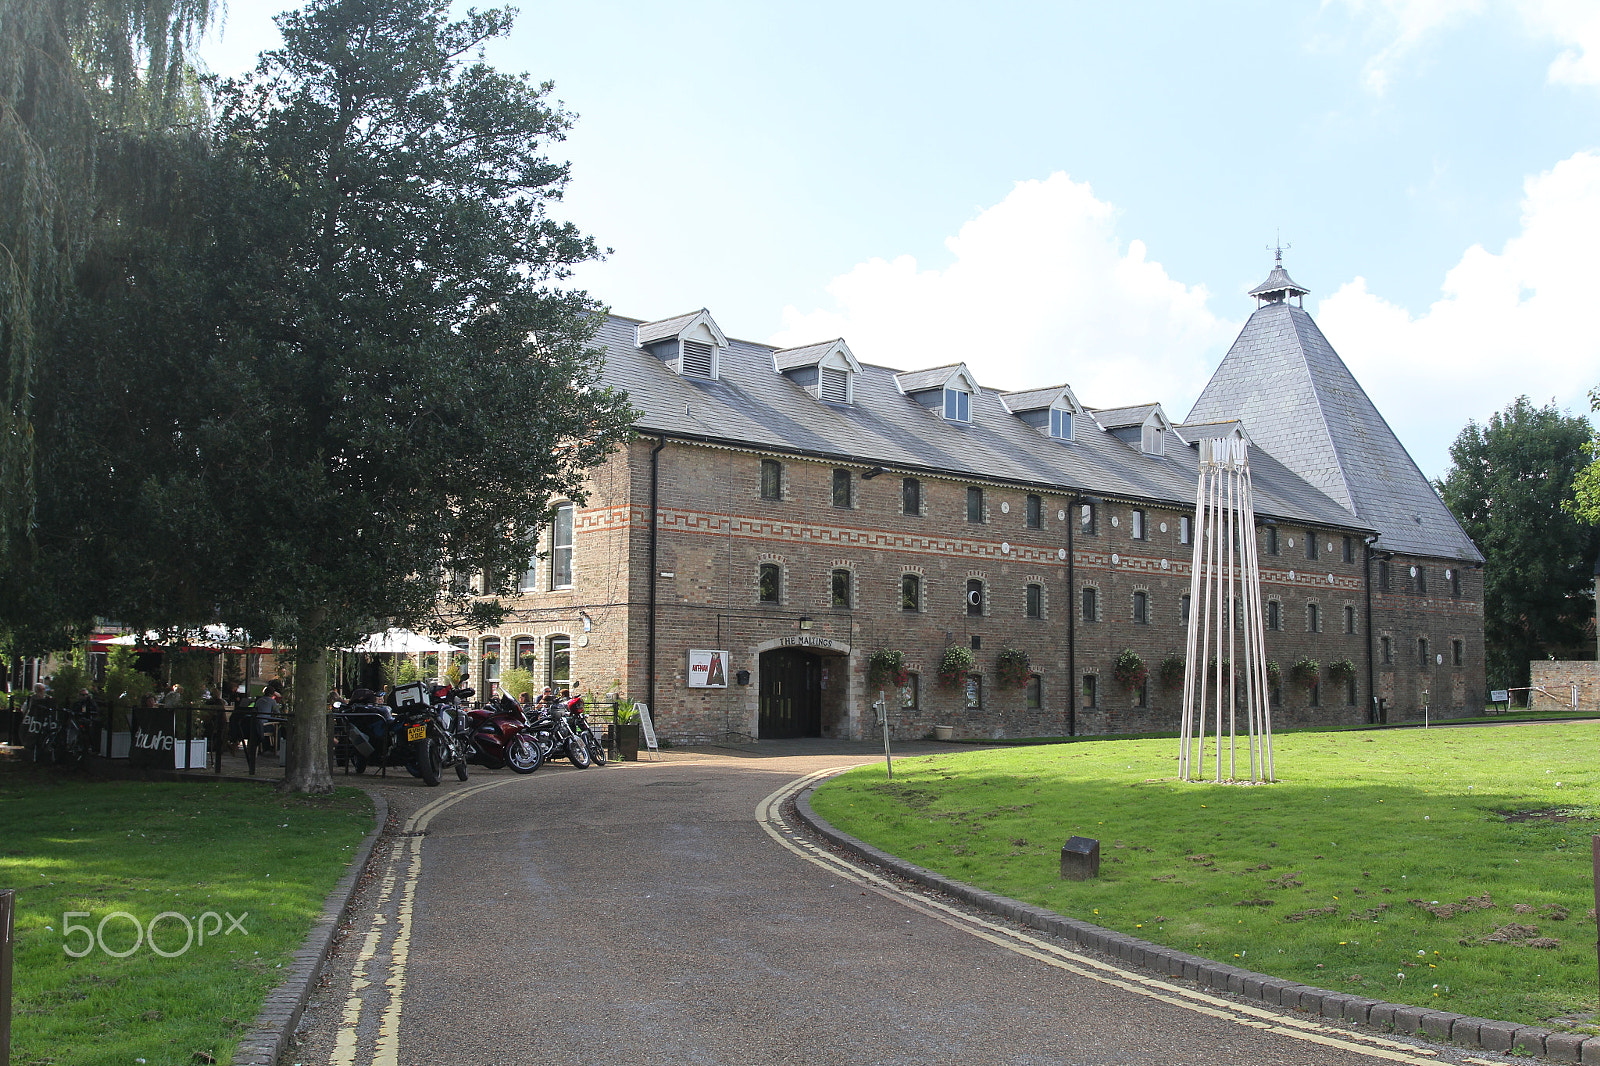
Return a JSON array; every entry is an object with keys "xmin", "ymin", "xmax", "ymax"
[{"xmin": 454, "ymin": 440, "xmax": 1483, "ymax": 739}]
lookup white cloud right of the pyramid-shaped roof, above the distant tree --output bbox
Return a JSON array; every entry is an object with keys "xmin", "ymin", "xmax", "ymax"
[{"xmin": 1317, "ymin": 152, "xmax": 1600, "ymax": 477}]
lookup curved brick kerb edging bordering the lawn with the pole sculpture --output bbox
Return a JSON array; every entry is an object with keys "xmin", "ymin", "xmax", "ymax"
[{"xmin": 795, "ymin": 781, "xmax": 1600, "ymax": 1066}]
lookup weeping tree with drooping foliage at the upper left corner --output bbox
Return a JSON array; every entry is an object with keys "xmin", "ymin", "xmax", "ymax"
[{"xmin": 0, "ymin": 0, "xmax": 213, "ymax": 563}]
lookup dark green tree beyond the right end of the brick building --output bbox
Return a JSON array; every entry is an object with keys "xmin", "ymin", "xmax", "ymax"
[{"xmin": 1438, "ymin": 397, "xmax": 1600, "ymax": 685}]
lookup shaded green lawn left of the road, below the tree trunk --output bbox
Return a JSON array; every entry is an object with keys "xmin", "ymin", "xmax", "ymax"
[{"xmin": 0, "ymin": 760, "xmax": 373, "ymax": 1066}]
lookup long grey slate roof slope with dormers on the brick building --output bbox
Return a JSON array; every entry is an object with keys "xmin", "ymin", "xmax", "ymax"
[{"xmin": 597, "ymin": 315, "xmax": 1368, "ymax": 531}]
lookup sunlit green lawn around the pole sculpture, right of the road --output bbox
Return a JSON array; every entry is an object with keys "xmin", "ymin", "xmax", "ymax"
[{"xmin": 813, "ymin": 723, "xmax": 1600, "ymax": 1023}]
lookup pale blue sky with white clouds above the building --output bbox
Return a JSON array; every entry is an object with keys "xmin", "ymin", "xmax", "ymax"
[{"xmin": 200, "ymin": 0, "xmax": 1600, "ymax": 477}]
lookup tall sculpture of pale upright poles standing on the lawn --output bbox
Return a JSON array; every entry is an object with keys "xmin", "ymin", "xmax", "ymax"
[{"xmin": 1178, "ymin": 434, "xmax": 1275, "ymax": 781}]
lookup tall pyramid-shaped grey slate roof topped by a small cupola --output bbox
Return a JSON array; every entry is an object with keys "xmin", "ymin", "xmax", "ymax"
[{"xmin": 1184, "ymin": 291, "xmax": 1483, "ymax": 562}]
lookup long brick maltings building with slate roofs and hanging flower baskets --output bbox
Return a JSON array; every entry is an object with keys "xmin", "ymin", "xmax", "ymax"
[{"xmin": 456, "ymin": 257, "xmax": 1483, "ymax": 739}]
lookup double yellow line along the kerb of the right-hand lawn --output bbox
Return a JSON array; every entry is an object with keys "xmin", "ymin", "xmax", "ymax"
[{"xmin": 755, "ymin": 767, "xmax": 1494, "ymax": 1066}]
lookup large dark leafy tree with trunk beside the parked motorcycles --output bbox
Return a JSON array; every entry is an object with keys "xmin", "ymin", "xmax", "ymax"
[{"xmin": 25, "ymin": 0, "xmax": 632, "ymax": 791}]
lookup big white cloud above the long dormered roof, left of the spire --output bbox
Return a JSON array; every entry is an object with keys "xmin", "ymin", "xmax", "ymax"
[{"xmin": 770, "ymin": 173, "xmax": 1238, "ymax": 418}]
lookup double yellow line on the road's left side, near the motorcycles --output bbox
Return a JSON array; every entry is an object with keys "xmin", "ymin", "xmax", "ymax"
[{"xmin": 328, "ymin": 778, "xmax": 520, "ymax": 1066}]
